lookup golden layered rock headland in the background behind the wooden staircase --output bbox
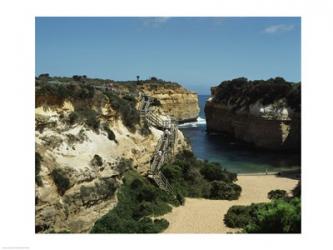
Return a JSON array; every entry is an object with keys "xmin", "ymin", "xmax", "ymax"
[{"xmin": 139, "ymin": 84, "xmax": 199, "ymax": 123}]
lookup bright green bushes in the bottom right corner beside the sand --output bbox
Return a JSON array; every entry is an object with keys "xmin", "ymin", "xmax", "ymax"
[{"xmin": 224, "ymin": 182, "xmax": 301, "ymax": 233}]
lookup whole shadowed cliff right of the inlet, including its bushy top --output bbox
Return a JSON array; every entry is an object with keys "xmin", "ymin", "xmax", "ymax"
[{"xmin": 205, "ymin": 78, "xmax": 301, "ymax": 151}]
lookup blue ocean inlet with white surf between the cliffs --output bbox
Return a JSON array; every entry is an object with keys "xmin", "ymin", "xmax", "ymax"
[{"xmin": 179, "ymin": 95, "xmax": 300, "ymax": 173}]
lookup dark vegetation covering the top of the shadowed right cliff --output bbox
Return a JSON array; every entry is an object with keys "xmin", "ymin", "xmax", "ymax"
[{"xmin": 212, "ymin": 77, "xmax": 301, "ymax": 112}]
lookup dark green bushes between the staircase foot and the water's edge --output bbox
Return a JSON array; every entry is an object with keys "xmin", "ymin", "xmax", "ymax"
[{"xmin": 162, "ymin": 151, "xmax": 241, "ymax": 200}]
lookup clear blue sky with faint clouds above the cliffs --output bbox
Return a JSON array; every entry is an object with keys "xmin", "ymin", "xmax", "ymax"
[{"xmin": 35, "ymin": 17, "xmax": 301, "ymax": 94}]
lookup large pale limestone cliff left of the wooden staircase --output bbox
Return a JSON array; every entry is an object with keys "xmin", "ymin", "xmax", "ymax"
[{"xmin": 35, "ymin": 83, "xmax": 189, "ymax": 233}]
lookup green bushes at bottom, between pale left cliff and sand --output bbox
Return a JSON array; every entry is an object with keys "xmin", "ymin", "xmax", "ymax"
[{"xmin": 91, "ymin": 170, "xmax": 179, "ymax": 233}]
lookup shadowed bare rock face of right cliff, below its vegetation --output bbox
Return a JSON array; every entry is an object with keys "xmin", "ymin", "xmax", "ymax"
[{"xmin": 205, "ymin": 98, "xmax": 301, "ymax": 151}]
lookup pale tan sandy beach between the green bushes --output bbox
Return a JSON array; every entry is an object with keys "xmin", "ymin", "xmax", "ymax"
[{"xmin": 163, "ymin": 175, "xmax": 298, "ymax": 233}]
